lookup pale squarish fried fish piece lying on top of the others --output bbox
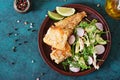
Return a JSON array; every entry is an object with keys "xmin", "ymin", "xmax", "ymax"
[{"xmin": 43, "ymin": 25, "xmax": 72, "ymax": 50}]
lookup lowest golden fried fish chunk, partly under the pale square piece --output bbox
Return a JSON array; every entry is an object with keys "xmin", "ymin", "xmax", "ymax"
[{"xmin": 50, "ymin": 43, "xmax": 72, "ymax": 64}]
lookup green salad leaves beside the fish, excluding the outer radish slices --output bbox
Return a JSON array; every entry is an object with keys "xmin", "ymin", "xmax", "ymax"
[{"xmin": 62, "ymin": 19, "xmax": 107, "ymax": 71}]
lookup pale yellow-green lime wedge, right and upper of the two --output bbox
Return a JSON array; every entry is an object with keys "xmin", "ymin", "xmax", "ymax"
[{"xmin": 56, "ymin": 7, "xmax": 75, "ymax": 16}]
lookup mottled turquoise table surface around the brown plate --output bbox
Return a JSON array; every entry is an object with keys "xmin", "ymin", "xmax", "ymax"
[{"xmin": 0, "ymin": 0, "xmax": 120, "ymax": 80}]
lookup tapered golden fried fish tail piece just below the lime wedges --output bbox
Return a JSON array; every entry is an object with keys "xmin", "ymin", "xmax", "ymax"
[{"xmin": 54, "ymin": 11, "xmax": 87, "ymax": 29}]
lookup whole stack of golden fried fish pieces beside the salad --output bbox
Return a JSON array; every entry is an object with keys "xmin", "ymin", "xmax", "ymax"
[{"xmin": 43, "ymin": 11, "xmax": 86, "ymax": 64}]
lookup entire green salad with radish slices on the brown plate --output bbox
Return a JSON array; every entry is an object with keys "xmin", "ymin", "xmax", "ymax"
[{"xmin": 62, "ymin": 19, "xmax": 107, "ymax": 72}]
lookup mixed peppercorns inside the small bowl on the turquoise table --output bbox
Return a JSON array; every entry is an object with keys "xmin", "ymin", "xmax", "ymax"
[{"xmin": 16, "ymin": 0, "xmax": 28, "ymax": 11}]
